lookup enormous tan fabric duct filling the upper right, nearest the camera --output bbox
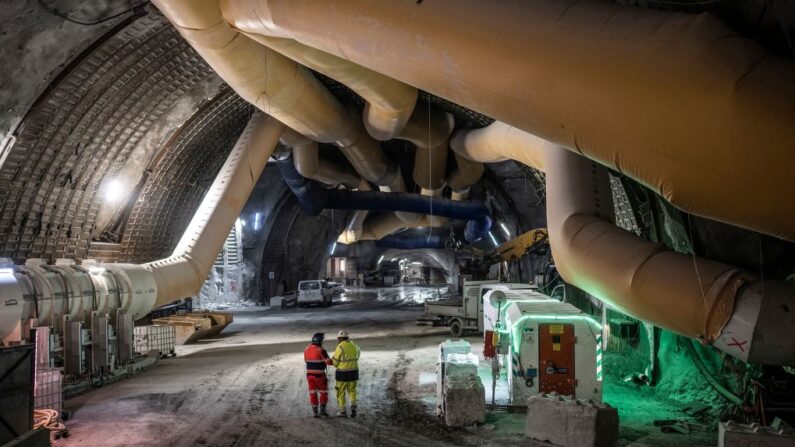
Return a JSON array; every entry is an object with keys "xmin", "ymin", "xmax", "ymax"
[{"xmin": 224, "ymin": 0, "xmax": 795, "ymax": 241}]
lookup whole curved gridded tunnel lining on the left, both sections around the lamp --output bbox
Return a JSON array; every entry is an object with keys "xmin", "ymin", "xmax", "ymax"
[{"xmin": 0, "ymin": 9, "xmax": 252, "ymax": 262}]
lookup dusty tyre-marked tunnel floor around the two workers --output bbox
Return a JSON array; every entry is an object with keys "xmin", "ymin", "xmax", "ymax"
[{"xmin": 55, "ymin": 288, "xmax": 712, "ymax": 447}]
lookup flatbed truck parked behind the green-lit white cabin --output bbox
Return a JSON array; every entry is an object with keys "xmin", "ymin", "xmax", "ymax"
[{"xmin": 417, "ymin": 280, "xmax": 535, "ymax": 337}]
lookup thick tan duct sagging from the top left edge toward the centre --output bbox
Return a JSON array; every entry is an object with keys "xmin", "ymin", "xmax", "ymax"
[{"xmin": 154, "ymin": 0, "xmax": 405, "ymax": 197}]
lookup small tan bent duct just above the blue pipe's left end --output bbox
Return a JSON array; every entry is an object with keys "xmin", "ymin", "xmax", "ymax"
[{"xmin": 280, "ymin": 129, "xmax": 361, "ymax": 189}]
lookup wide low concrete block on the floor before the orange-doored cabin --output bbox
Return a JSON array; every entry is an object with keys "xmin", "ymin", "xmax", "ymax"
[{"xmin": 525, "ymin": 393, "xmax": 618, "ymax": 447}]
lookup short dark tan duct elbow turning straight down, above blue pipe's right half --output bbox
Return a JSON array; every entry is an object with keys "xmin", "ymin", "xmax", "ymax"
[{"xmin": 398, "ymin": 104, "xmax": 454, "ymax": 196}]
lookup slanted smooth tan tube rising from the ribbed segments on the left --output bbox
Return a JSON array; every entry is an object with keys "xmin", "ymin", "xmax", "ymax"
[{"xmin": 144, "ymin": 114, "xmax": 285, "ymax": 306}]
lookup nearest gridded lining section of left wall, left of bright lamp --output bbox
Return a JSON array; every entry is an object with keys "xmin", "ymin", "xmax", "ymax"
[{"xmin": 0, "ymin": 14, "xmax": 212, "ymax": 261}]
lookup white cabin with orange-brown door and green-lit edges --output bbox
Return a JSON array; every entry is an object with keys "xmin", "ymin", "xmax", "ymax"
[{"xmin": 499, "ymin": 300, "xmax": 602, "ymax": 406}]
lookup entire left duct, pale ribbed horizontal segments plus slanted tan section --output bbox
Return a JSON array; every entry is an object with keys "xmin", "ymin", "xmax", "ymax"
[{"xmin": 0, "ymin": 114, "xmax": 284, "ymax": 341}]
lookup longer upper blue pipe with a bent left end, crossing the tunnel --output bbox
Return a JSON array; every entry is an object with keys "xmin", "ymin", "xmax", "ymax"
[{"xmin": 277, "ymin": 156, "xmax": 492, "ymax": 243}]
